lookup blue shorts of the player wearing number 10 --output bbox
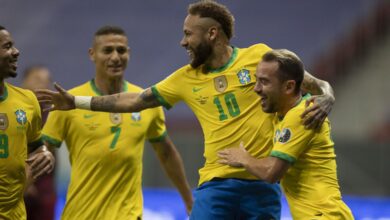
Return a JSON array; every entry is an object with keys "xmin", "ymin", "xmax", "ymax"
[{"xmin": 190, "ymin": 178, "xmax": 281, "ymax": 220}]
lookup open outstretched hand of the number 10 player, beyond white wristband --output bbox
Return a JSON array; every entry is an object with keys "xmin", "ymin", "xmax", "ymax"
[{"xmin": 34, "ymin": 83, "xmax": 76, "ymax": 112}]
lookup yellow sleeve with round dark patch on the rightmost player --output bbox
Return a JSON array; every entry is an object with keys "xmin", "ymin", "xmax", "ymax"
[{"xmin": 271, "ymin": 108, "xmax": 315, "ymax": 163}]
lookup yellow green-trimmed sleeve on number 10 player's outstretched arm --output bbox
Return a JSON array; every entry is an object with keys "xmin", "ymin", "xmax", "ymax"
[{"xmin": 151, "ymin": 68, "xmax": 185, "ymax": 109}]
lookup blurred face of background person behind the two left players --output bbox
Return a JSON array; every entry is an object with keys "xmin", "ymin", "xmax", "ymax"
[{"xmin": 23, "ymin": 68, "xmax": 51, "ymax": 90}]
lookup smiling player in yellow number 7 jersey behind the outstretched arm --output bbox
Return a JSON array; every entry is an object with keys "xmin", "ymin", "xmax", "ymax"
[{"xmin": 43, "ymin": 26, "xmax": 192, "ymax": 220}]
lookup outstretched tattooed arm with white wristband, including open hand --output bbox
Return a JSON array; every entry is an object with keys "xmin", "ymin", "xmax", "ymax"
[{"xmin": 36, "ymin": 84, "xmax": 161, "ymax": 112}]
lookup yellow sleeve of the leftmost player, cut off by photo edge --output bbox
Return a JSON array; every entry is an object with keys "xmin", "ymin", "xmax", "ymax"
[{"xmin": 27, "ymin": 91, "xmax": 43, "ymax": 150}]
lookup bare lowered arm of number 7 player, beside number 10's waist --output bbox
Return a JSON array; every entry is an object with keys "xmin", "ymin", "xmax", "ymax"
[{"xmin": 152, "ymin": 136, "xmax": 193, "ymax": 213}]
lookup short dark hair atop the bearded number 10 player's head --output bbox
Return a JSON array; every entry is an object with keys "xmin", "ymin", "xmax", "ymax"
[{"xmin": 188, "ymin": 0, "xmax": 234, "ymax": 40}]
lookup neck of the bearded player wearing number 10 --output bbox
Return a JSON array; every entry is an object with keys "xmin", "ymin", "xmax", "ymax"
[{"xmin": 206, "ymin": 44, "xmax": 233, "ymax": 69}]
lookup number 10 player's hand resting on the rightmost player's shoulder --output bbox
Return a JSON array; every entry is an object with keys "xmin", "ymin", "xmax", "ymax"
[{"xmin": 301, "ymin": 95, "xmax": 335, "ymax": 129}]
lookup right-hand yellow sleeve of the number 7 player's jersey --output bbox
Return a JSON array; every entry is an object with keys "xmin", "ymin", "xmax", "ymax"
[{"xmin": 146, "ymin": 107, "xmax": 167, "ymax": 143}]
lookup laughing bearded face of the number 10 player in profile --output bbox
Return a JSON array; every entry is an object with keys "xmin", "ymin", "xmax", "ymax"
[{"xmin": 180, "ymin": 15, "xmax": 212, "ymax": 68}]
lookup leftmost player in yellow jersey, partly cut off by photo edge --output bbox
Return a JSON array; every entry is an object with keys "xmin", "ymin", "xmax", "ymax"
[{"xmin": 0, "ymin": 26, "xmax": 54, "ymax": 220}]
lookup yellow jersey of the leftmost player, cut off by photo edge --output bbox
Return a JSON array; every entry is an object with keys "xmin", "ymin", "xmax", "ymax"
[{"xmin": 0, "ymin": 83, "xmax": 42, "ymax": 220}]
